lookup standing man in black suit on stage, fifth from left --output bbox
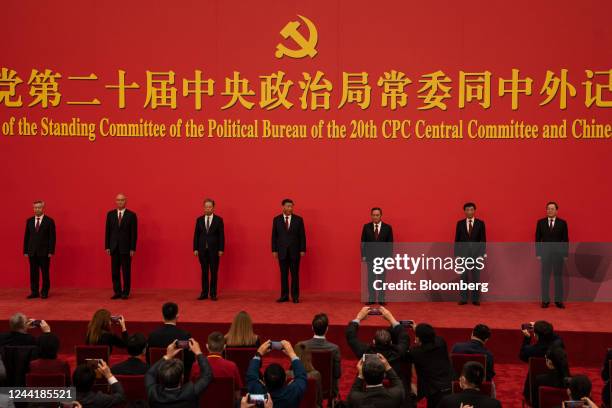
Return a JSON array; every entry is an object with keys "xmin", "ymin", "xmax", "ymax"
[{"xmin": 361, "ymin": 207, "xmax": 393, "ymax": 305}]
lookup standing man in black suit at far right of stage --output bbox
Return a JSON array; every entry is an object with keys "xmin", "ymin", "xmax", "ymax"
[{"xmin": 535, "ymin": 201, "xmax": 569, "ymax": 309}]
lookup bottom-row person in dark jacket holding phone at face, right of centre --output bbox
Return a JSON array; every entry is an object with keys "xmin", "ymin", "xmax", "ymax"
[{"xmin": 346, "ymin": 353, "xmax": 405, "ymax": 408}]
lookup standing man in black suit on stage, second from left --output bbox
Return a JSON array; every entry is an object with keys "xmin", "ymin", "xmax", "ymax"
[{"xmin": 104, "ymin": 194, "xmax": 138, "ymax": 299}]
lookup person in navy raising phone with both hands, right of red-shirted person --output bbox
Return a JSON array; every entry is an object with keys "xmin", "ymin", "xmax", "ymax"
[{"xmin": 246, "ymin": 340, "xmax": 308, "ymax": 408}]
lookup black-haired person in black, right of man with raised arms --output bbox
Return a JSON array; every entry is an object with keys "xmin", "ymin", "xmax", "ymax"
[{"xmin": 410, "ymin": 323, "xmax": 453, "ymax": 408}]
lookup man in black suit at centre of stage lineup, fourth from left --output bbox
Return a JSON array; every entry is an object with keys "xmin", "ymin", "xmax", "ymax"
[{"xmin": 272, "ymin": 198, "xmax": 306, "ymax": 303}]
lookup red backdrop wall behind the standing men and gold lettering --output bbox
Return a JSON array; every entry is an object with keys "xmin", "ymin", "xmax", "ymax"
[{"xmin": 0, "ymin": 0, "xmax": 612, "ymax": 291}]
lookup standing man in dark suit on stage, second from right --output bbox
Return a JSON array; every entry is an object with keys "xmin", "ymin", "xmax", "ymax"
[{"xmin": 455, "ymin": 203, "xmax": 487, "ymax": 306}]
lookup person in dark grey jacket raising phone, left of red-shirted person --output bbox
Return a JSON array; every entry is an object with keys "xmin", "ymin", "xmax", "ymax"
[{"xmin": 145, "ymin": 339, "xmax": 213, "ymax": 408}]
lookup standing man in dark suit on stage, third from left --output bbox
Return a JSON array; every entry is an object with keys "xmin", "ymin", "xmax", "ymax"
[{"xmin": 193, "ymin": 198, "xmax": 225, "ymax": 300}]
